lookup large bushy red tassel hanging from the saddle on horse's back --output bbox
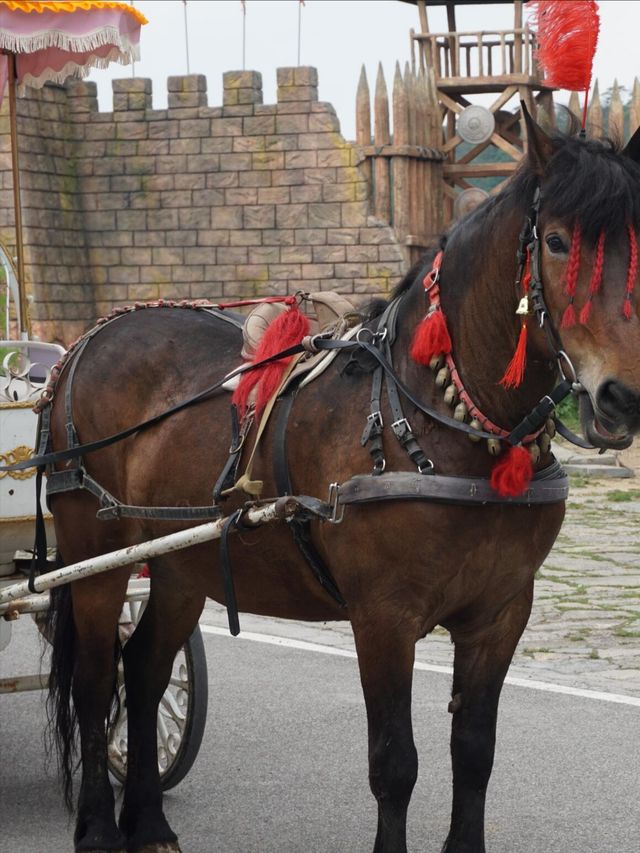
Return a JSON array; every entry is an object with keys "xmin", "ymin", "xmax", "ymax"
[{"xmin": 232, "ymin": 305, "xmax": 310, "ymax": 417}]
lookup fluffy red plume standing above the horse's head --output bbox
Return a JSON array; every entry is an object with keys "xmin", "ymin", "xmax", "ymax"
[{"xmin": 530, "ymin": 0, "xmax": 600, "ymax": 92}]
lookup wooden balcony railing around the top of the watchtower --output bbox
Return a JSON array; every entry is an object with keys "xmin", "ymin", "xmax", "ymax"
[{"xmin": 411, "ymin": 26, "xmax": 538, "ymax": 80}]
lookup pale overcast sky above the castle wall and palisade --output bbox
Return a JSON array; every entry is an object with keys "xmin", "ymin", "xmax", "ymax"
[{"xmin": 90, "ymin": 0, "xmax": 640, "ymax": 139}]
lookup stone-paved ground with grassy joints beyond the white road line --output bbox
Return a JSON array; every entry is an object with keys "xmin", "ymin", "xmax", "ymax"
[{"xmin": 202, "ymin": 440, "xmax": 640, "ymax": 696}]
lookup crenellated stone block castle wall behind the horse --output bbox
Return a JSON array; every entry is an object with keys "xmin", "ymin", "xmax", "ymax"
[{"xmin": 0, "ymin": 68, "xmax": 405, "ymax": 344}]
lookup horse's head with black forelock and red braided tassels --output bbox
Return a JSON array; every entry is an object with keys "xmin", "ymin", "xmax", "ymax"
[{"xmin": 527, "ymin": 111, "xmax": 640, "ymax": 448}]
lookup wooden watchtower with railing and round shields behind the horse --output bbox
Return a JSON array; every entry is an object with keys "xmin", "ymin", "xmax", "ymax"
[{"xmin": 403, "ymin": 0, "xmax": 553, "ymax": 221}]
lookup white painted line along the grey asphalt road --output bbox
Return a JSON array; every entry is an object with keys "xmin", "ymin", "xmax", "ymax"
[{"xmin": 200, "ymin": 625, "xmax": 640, "ymax": 708}]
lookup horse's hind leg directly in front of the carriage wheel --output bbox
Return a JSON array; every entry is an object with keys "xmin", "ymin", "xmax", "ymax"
[{"xmin": 120, "ymin": 558, "xmax": 204, "ymax": 853}]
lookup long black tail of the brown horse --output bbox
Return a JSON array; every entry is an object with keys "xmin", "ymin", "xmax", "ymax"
[{"xmin": 44, "ymin": 554, "xmax": 78, "ymax": 810}]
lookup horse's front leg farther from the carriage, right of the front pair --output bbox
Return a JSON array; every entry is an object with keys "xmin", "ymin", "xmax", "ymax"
[{"xmin": 442, "ymin": 584, "xmax": 533, "ymax": 853}]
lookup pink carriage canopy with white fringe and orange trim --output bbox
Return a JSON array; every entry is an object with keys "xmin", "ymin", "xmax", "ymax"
[{"xmin": 0, "ymin": 2, "xmax": 146, "ymax": 91}]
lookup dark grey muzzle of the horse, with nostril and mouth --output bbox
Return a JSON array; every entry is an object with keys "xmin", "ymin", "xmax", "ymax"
[{"xmin": 579, "ymin": 379, "xmax": 640, "ymax": 450}]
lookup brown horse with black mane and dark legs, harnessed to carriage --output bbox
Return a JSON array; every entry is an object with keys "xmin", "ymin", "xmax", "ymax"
[{"xmin": 43, "ymin": 119, "xmax": 640, "ymax": 853}]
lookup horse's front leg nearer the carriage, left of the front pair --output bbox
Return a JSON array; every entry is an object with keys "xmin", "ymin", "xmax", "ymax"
[{"xmin": 352, "ymin": 618, "xmax": 418, "ymax": 853}]
